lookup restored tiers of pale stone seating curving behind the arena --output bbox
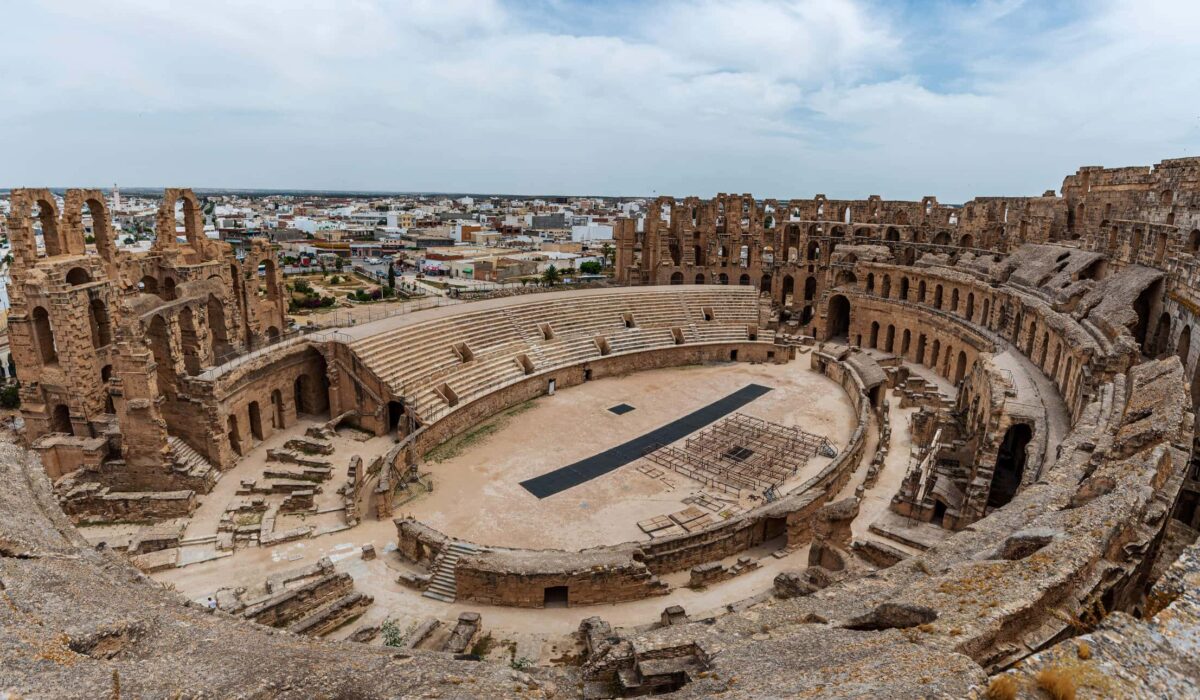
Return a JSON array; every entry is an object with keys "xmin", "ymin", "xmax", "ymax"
[{"xmin": 353, "ymin": 287, "xmax": 770, "ymax": 418}]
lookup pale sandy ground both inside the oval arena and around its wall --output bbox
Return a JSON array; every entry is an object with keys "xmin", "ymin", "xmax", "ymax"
[{"xmin": 140, "ymin": 355, "xmax": 873, "ymax": 662}]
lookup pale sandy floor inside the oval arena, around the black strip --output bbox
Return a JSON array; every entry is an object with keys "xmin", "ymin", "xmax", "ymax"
[{"xmin": 397, "ymin": 358, "xmax": 853, "ymax": 550}]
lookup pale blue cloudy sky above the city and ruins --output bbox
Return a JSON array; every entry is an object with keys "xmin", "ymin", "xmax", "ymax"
[{"xmin": 0, "ymin": 0, "xmax": 1200, "ymax": 203}]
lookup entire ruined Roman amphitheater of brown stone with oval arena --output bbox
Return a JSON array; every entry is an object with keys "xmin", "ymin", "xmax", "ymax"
[{"xmin": 0, "ymin": 158, "xmax": 1200, "ymax": 698}]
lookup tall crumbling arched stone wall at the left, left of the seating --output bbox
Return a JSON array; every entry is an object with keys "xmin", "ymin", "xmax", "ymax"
[{"xmin": 8, "ymin": 189, "xmax": 286, "ymax": 487}]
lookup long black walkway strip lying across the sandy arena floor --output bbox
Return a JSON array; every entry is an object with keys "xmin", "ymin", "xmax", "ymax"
[{"xmin": 521, "ymin": 384, "xmax": 770, "ymax": 498}]
